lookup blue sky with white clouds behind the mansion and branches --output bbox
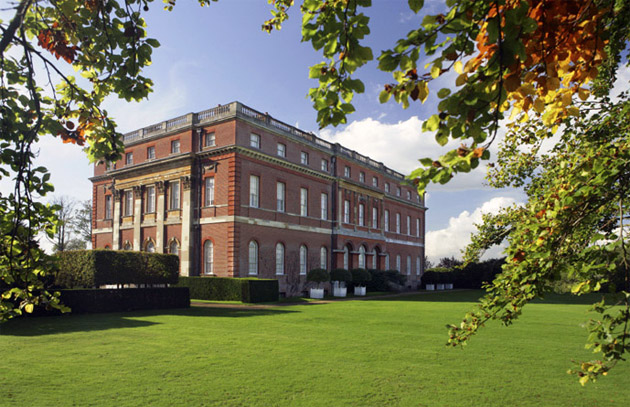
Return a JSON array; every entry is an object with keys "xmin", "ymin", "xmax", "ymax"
[{"xmin": 2, "ymin": 0, "xmax": 523, "ymax": 260}]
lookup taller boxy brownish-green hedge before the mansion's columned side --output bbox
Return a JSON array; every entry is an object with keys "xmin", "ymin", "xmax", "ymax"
[{"xmin": 54, "ymin": 250, "xmax": 179, "ymax": 288}]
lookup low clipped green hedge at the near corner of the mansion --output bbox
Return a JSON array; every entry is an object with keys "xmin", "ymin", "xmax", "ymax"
[{"xmin": 177, "ymin": 277, "xmax": 279, "ymax": 302}]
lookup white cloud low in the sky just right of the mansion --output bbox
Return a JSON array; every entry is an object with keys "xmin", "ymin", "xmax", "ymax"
[{"xmin": 425, "ymin": 197, "xmax": 516, "ymax": 262}]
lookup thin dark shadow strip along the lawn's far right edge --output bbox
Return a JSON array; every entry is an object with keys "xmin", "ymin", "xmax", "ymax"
[{"xmin": 371, "ymin": 290, "xmax": 617, "ymax": 305}]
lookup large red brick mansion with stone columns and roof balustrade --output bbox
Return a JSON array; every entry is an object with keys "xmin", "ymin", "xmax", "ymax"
[{"xmin": 91, "ymin": 102, "xmax": 426, "ymax": 293}]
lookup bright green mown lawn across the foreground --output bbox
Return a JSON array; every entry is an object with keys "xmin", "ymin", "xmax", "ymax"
[{"xmin": 0, "ymin": 291, "xmax": 630, "ymax": 407}]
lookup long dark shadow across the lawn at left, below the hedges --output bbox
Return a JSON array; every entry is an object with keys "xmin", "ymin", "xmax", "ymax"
[{"xmin": 0, "ymin": 307, "xmax": 299, "ymax": 336}]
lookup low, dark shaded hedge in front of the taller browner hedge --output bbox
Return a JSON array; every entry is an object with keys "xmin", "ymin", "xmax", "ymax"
[{"xmin": 34, "ymin": 287, "xmax": 190, "ymax": 315}]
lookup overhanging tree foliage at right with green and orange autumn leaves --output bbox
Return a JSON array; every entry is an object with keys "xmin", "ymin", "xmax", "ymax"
[{"xmin": 263, "ymin": 0, "xmax": 630, "ymax": 384}]
